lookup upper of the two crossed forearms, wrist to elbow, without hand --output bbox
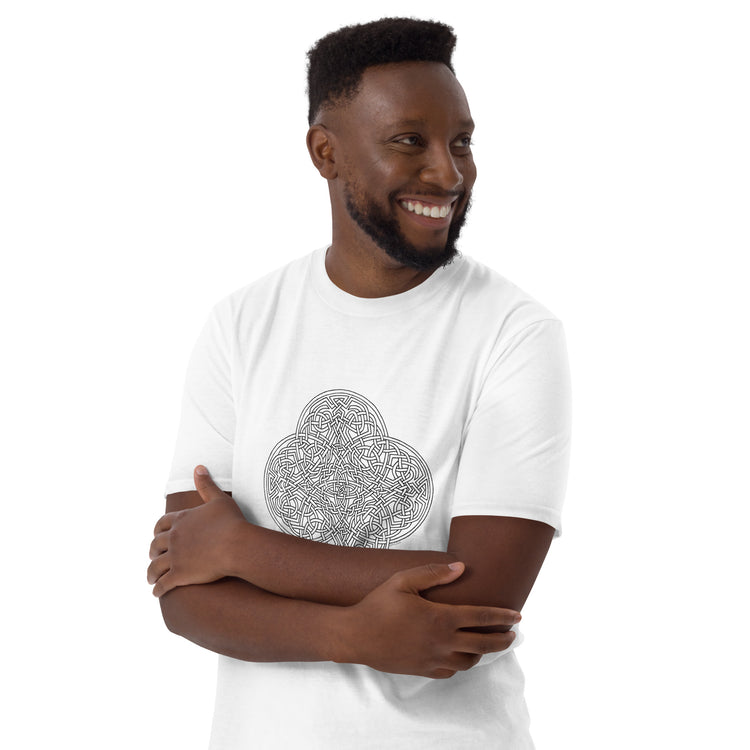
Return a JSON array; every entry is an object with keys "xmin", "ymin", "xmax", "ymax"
[{"xmin": 227, "ymin": 524, "xmax": 457, "ymax": 606}]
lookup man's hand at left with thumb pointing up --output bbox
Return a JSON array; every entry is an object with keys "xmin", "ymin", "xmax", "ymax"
[{"xmin": 148, "ymin": 466, "xmax": 247, "ymax": 596}]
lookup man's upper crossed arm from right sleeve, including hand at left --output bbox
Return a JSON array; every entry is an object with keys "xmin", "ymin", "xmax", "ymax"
[{"xmin": 149, "ymin": 472, "xmax": 554, "ymax": 611}]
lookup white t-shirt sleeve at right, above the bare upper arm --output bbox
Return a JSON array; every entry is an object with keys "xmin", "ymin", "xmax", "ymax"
[{"xmin": 452, "ymin": 319, "xmax": 571, "ymax": 536}]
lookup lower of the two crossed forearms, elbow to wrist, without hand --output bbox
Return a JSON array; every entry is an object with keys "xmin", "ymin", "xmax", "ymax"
[{"xmin": 160, "ymin": 578, "xmax": 344, "ymax": 661}]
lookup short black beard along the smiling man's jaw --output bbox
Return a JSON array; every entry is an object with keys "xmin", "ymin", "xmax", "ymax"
[{"xmin": 345, "ymin": 185, "xmax": 471, "ymax": 271}]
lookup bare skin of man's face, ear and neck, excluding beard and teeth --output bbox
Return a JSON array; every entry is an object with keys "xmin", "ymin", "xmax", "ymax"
[{"xmin": 307, "ymin": 63, "xmax": 476, "ymax": 297}]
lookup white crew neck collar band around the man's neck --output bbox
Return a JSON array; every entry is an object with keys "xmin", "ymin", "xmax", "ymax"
[{"xmin": 310, "ymin": 245, "xmax": 462, "ymax": 317}]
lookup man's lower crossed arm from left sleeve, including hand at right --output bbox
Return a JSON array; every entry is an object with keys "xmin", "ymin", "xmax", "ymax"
[{"xmin": 160, "ymin": 492, "xmax": 516, "ymax": 677}]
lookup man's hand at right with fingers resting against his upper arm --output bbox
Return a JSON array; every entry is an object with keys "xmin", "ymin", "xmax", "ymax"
[{"xmin": 339, "ymin": 563, "xmax": 521, "ymax": 678}]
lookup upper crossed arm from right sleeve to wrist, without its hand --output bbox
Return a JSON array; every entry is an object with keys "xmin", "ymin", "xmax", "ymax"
[{"xmin": 220, "ymin": 516, "xmax": 554, "ymax": 624}]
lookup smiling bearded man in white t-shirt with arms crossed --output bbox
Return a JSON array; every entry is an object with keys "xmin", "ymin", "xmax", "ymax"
[{"xmin": 148, "ymin": 19, "xmax": 569, "ymax": 750}]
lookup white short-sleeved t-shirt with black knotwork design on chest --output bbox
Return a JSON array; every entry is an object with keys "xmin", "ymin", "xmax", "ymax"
[{"xmin": 166, "ymin": 248, "xmax": 570, "ymax": 750}]
